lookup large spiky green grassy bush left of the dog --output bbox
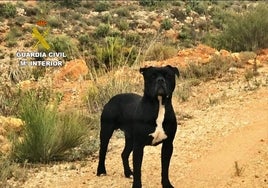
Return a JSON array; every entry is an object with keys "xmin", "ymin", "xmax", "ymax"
[{"xmin": 11, "ymin": 91, "xmax": 87, "ymax": 163}]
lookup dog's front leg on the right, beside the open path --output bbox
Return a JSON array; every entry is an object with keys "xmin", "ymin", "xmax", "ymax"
[{"xmin": 161, "ymin": 140, "xmax": 173, "ymax": 188}]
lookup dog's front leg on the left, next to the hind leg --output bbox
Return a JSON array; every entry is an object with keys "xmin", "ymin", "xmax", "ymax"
[{"xmin": 132, "ymin": 145, "xmax": 144, "ymax": 188}]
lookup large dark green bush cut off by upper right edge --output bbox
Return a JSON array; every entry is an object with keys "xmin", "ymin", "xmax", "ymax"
[{"xmin": 215, "ymin": 4, "xmax": 268, "ymax": 51}]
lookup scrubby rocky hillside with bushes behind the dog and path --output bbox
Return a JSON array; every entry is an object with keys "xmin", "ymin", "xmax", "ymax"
[{"xmin": 0, "ymin": 0, "xmax": 268, "ymax": 187}]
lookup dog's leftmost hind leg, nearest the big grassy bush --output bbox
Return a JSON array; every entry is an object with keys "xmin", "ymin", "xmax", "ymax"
[{"xmin": 97, "ymin": 122, "xmax": 114, "ymax": 176}]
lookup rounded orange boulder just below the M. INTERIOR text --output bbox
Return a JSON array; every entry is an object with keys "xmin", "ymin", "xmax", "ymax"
[{"xmin": 54, "ymin": 59, "xmax": 89, "ymax": 81}]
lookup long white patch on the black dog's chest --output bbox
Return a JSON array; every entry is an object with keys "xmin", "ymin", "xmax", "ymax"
[{"xmin": 149, "ymin": 96, "xmax": 167, "ymax": 145}]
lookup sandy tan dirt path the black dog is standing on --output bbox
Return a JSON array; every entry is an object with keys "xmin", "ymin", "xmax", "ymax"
[{"xmin": 19, "ymin": 83, "xmax": 268, "ymax": 188}]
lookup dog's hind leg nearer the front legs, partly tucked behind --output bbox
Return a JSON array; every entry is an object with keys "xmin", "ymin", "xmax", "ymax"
[{"xmin": 121, "ymin": 135, "xmax": 133, "ymax": 178}]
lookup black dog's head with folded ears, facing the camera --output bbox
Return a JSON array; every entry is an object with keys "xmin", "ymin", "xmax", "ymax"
[{"xmin": 140, "ymin": 65, "xmax": 180, "ymax": 98}]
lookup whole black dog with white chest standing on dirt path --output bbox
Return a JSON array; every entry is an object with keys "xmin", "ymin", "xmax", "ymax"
[{"xmin": 97, "ymin": 65, "xmax": 179, "ymax": 188}]
